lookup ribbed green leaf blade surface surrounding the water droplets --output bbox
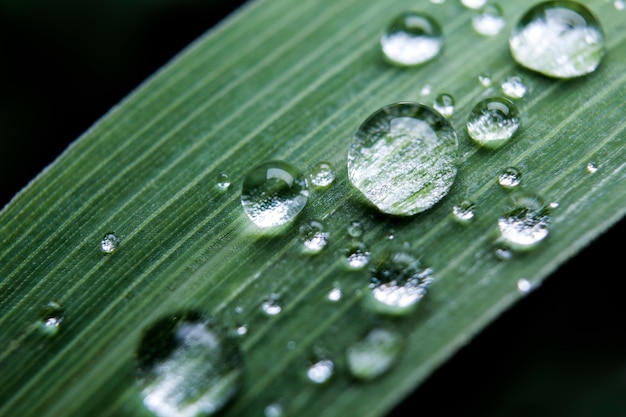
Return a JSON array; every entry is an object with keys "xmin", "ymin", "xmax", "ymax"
[{"xmin": 0, "ymin": 0, "xmax": 626, "ymax": 416}]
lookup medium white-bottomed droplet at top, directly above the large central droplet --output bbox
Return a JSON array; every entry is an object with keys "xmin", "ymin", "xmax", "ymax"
[{"xmin": 380, "ymin": 12, "xmax": 443, "ymax": 66}]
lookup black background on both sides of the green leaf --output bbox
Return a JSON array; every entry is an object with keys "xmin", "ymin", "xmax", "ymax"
[{"xmin": 0, "ymin": 0, "xmax": 626, "ymax": 417}]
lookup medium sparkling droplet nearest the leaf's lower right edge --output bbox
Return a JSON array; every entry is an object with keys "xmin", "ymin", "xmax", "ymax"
[{"xmin": 498, "ymin": 193, "xmax": 551, "ymax": 250}]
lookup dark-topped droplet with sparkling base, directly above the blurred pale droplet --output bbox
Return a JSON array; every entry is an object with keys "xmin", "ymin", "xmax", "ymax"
[{"xmin": 366, "ymin": 252, "xmax": 433, "ymax": 315}]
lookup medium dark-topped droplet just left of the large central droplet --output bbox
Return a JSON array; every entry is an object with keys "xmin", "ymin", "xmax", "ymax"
[{"xmin": 241, "ymin": 161, "xmax": 309, "ymax": 228}]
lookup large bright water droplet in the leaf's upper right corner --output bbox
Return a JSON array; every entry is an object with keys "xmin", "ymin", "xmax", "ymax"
[{"xmin": 509, "ymin": 1, "xmax": 605, "ymax": 78}]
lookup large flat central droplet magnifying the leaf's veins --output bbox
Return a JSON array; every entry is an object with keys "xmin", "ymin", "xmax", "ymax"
[{"xmin": 348, "ymin": 102, "xmax": 458, "ymax": 216}]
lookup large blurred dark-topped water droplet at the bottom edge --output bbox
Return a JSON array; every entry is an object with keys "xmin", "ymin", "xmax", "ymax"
[{"xmin": 136, "ymin": 311, "xmax": 243, "ymax": 417}]
